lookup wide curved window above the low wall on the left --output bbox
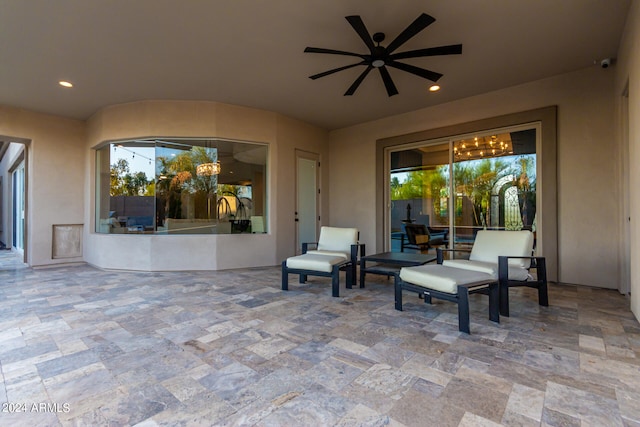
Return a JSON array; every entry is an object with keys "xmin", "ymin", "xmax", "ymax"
[{"xmin": 96, "ymin": 138, "xmax": 268, "ymax": 234}]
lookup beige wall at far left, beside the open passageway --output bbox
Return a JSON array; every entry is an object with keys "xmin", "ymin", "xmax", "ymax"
[{"xmin": 0, "ymin": 106, "xmax": 86, "ymax": 266}]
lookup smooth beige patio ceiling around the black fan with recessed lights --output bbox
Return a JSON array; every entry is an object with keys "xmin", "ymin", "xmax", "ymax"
[{"xmin": 0, "ymin": 0, "xmax": 630, "ymax": 130}]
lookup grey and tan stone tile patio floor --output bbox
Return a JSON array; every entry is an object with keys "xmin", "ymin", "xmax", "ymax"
[{"xmin": 0, "ymin": 256, "xmax": 640, "ymax": 427}]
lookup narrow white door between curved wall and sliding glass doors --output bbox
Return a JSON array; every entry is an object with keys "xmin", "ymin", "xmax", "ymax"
[{"xmin": 295, "ymin": 151, "xmax": 320, "ymax": 254}]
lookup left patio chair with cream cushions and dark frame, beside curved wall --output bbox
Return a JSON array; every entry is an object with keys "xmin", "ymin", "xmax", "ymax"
[{"xmin": 282, "ymin": 226, "xmax": 358, "ymax": 297}]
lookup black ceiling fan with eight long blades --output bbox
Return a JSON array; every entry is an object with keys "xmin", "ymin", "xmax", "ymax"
[{"xmin": 304, "ymin": 13, "xmax": 462, "ymax": 96}]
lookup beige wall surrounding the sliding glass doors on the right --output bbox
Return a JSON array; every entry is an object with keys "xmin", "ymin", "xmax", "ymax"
[{"xmin": 329, "ymin": 66, "xmax": 620, "ymax": 288}]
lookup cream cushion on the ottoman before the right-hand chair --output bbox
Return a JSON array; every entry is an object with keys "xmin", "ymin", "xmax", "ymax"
[{"xmin": 400, "ymin": 264, "xmax": 495, "ymax": 294}]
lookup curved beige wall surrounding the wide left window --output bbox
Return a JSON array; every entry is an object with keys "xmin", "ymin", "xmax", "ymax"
[{"xmin": 85, "ymin": 101, "xmax": 328, "ymax": 270}]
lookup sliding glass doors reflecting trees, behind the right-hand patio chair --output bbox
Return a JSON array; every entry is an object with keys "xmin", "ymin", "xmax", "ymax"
[{"xmin": 389, "ymin": 127, "xmax": 538, "ymax": 251}]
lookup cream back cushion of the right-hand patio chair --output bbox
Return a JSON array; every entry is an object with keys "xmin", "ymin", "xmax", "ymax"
[{"xmin": 469, "ymin": 230, "xmax": 533, "ymax": 268}]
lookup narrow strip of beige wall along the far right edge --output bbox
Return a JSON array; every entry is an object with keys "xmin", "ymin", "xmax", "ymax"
[{"xmin": 614, "ymin": 1, "xmax": 640, "ymax": 319}]
